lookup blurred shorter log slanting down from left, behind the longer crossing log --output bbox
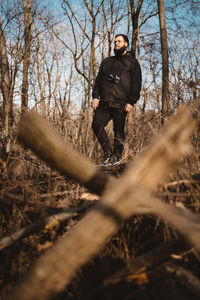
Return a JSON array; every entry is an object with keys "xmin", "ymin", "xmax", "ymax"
[{"xmin": 18, "ymin": 112, "xmax": 109, "ymax": 194}]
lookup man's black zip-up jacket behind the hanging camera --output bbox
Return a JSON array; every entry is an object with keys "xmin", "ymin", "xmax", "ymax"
[{"xmin": 92, "ymin": 52, "xmax": 142, "ymax": 105}]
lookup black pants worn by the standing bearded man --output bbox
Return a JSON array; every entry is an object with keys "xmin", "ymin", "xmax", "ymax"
[{"xmin": 92, "ymin": 102, "xmax": 127, "ymax": 158}]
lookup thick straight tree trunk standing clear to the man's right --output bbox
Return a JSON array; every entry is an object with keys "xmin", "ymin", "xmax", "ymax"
[{"xmin": 157, "ymin": 0, "xmax": 170, "ymax": 123}]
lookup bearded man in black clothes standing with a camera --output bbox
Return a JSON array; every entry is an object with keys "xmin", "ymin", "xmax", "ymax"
[{"xmin": 92, "ymin": 34, "xmax": 142, "ymax": 166}]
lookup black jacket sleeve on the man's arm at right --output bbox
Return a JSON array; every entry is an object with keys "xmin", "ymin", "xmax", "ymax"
[{"xmin": 127, "ymin": 58, "xmax": 142, "ymax": 105}]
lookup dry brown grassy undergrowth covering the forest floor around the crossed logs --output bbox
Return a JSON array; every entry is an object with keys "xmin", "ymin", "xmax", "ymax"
[{"xmin": 0, "ymin": 102, "xmax": 200, "ymax": 300}]
